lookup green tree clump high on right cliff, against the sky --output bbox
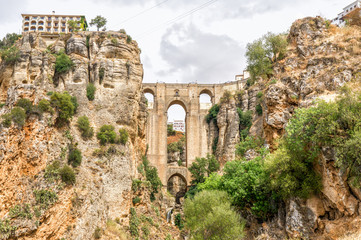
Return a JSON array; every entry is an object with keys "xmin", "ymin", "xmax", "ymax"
[{"xmin": 246, "ymin": 33, "xmax": 288, "ymax": 82}]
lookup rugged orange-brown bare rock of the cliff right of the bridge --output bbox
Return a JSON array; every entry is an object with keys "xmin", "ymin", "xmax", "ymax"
[{"xmin": 209, "ymin": 17, "xmax": 361, "ymax": 239}]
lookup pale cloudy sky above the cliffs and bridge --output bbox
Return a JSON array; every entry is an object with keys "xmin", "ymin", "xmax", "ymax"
[{"xmin": 0, "ymin": 0, "xmax": 352, "ymax": 120}]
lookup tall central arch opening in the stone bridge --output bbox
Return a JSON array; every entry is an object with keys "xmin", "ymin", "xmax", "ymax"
[{"xmin": 166, "ymin": 101, "xmax": 187, "ymax": 167}]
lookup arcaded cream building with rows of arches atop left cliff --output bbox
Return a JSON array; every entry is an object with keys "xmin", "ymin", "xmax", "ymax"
[{"xmin": 21, "ymin": 12, "xmax": 88, "ymax": 34}]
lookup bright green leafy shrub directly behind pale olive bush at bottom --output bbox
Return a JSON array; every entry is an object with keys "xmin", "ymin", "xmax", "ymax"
[{"xmin": 198, "ymin": 157, "xmax": 279, "ymax": 220}]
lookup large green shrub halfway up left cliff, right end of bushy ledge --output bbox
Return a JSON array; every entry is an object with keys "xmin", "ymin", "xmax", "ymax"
[{"xmin": 50, "ymin": 92, "xmax": 76, "ymax": 124}]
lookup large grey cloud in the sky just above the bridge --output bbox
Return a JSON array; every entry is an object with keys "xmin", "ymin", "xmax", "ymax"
[{"xmin": 157, "ymin": 24, "xmax": 244, "ymax": 83}]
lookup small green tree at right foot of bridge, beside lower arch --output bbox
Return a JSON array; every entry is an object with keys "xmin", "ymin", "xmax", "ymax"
[{"xmin": 188, "ymin": 154, "xmax": 220, "ymax": 184}]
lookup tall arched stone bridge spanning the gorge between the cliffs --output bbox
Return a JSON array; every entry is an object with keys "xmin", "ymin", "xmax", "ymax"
[{"xmin": 143, "ymin": 80, "xmax": 245, "ymax": 186}]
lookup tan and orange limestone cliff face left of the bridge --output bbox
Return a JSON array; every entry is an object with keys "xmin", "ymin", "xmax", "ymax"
[{"xmin": 0, "ymin": 32, "xmax": 147, "ymax": 239}]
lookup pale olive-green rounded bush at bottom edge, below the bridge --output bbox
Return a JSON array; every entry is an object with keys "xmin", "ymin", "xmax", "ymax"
[{"xmin": 184, "ymin": 191, "xmax": 244, "ymax": 240}]
